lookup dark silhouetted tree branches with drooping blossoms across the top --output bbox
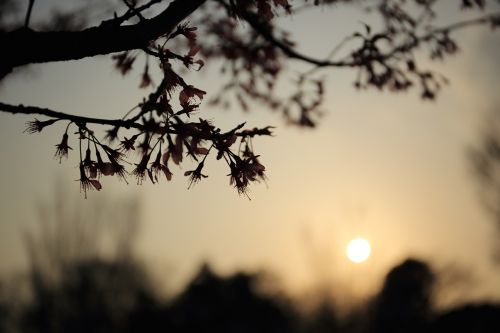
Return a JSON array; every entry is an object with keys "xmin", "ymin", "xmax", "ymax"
[{"xmin": 0, "ymin": 0, "xmax": 500, "ymax": 195}]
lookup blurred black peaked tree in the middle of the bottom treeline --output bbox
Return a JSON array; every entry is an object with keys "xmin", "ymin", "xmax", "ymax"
[{"xmin": 169, "ymin": 265, "xmax": 294, "ymax": 333}]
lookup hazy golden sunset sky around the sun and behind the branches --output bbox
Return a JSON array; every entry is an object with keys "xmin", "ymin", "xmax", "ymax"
[{"xmin": 0, "ymin": 1, "xmax": 500, "ymax": 308}]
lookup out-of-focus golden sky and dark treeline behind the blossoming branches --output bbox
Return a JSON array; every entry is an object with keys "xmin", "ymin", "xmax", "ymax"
[{"xmin": 0, "ymin": 1, "xmax": 500, "ymax": 332}]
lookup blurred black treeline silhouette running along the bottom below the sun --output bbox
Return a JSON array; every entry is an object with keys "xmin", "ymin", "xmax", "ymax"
[{"xmin": 0, "ymin": 243, "xmax": 500, "ymax": 333}]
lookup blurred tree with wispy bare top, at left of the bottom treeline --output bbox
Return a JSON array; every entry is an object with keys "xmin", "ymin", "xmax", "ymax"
[{"xmin": 20, "ymin": 190, "xmax": 159, "ymax": 332}]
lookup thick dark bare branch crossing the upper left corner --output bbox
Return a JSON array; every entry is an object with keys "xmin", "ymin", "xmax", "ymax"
[{"xmin": 0, "ymin": 0, "xmax": 205, "ymax": 78}]
